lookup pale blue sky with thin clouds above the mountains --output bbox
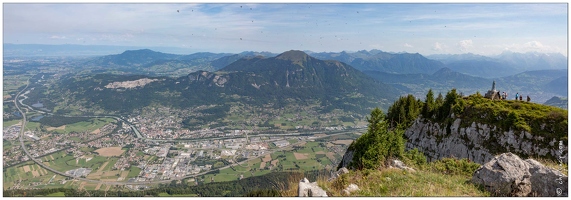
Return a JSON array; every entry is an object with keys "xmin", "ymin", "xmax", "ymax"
[{"xmin": 2, "ymin": 3, "xmax": 568, "ymax": 55}]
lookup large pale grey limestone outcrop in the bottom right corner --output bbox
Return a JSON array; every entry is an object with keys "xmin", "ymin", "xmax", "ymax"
[{"xmin": 471, "ymin": 153, "xmax": 568, "ymax": 197}]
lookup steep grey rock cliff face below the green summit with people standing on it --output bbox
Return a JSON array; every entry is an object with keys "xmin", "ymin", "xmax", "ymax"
[{"xmin": 405, "ymin": 117, "xmax": 567, "ymax": 164}]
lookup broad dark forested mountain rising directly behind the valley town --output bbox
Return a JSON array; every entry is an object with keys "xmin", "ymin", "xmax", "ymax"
[{"xmin": 47, "ymin": 51, "xmax": 399, "ymax": 113}]
